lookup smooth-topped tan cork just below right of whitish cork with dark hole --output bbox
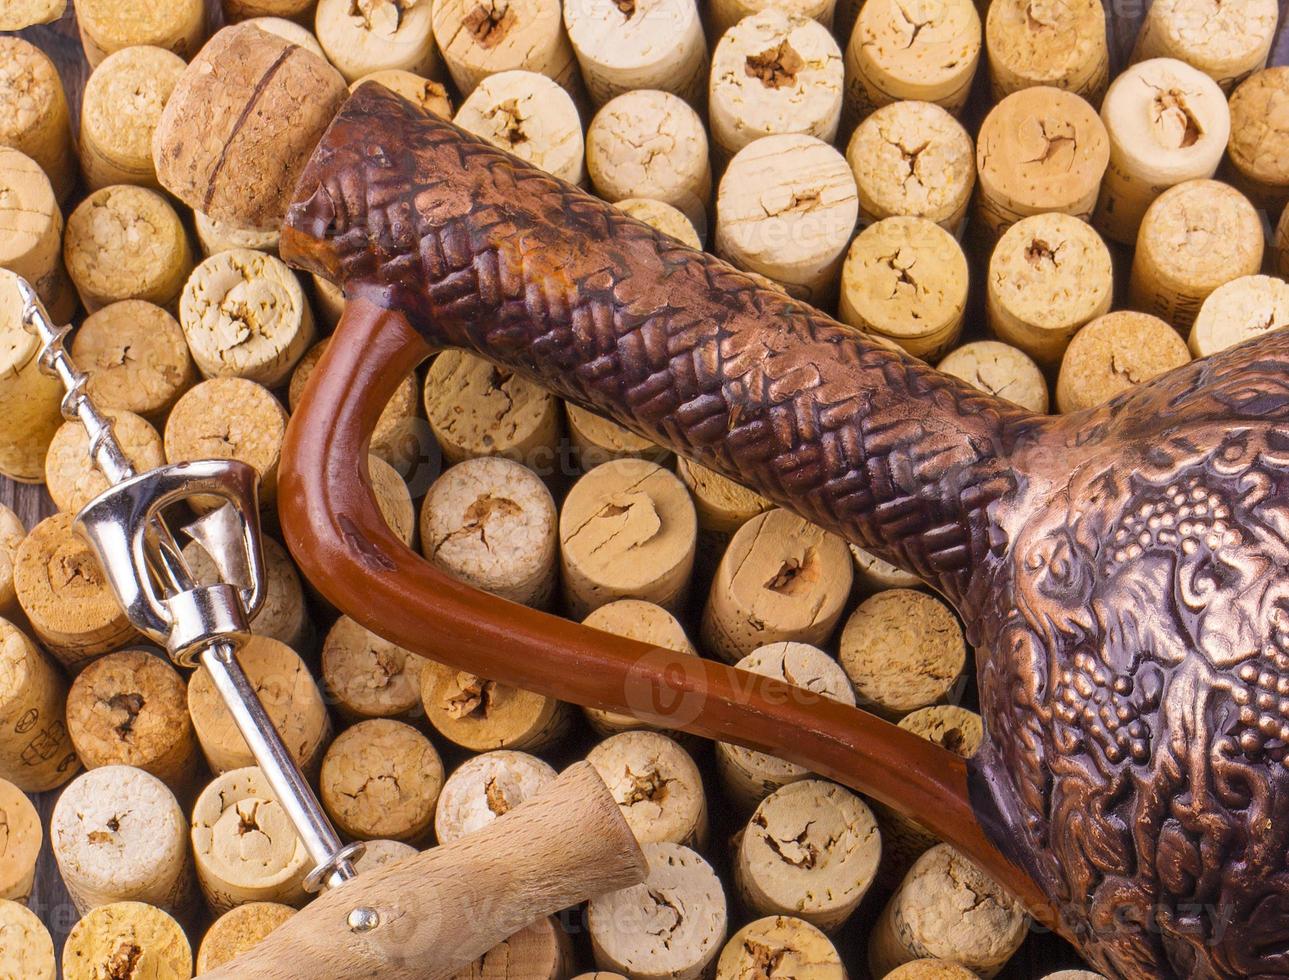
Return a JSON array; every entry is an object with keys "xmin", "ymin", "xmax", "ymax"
[{"xmin": 1128, "ymin": 181, "xmax": 1266, "ymax": 333}]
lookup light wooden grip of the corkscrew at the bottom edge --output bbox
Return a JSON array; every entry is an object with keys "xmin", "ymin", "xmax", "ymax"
[{"xmin": 205, "ymin": 762, "xmax": 646, "ymax": 980}]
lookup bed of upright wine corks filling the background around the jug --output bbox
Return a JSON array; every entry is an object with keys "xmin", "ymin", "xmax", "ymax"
[{"xmin": 0, "ymin": 0, "xmax": 1289, "ymax": 980}]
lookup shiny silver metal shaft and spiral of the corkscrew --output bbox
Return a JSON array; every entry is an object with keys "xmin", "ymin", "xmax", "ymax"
[{"xmin": 18, "ymin": 277, "xmax": 363, "ymax": 892}]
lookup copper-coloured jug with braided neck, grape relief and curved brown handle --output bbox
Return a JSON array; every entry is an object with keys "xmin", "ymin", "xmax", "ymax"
[{"xmin": 280, "ymin": 85, "xmax": 1289, "ymax": 977}]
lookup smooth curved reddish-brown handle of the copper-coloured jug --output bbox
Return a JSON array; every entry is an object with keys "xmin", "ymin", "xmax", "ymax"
[{"xmin": 278, "ymin": 298, "xmax": 1043, "ymax": 909}]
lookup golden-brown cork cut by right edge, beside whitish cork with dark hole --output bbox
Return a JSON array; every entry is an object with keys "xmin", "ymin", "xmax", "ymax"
[{"xmin": 1226, "ymin": 67, "xmax": 1289, "ymax": 218}]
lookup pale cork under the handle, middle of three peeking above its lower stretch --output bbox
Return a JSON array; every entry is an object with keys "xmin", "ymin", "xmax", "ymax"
[{"xmin": 717, "ymin": 642, "xmax": 855, "ymax": 812}]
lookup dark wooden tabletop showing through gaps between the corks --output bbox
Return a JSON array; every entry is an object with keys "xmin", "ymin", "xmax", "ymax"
[{"xmin": 0, "ymin": 0, "xmax": 1289, "ymax": 980}]
